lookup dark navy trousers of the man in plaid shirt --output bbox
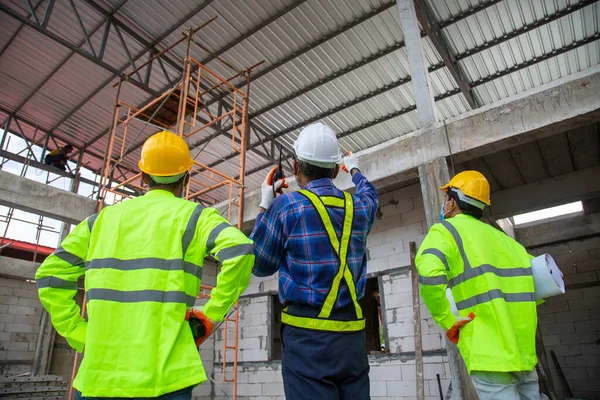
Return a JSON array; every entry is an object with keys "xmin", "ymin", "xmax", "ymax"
[{"xmin": 281, "ymin": 304, "xmax": 370, "ymax": 400}]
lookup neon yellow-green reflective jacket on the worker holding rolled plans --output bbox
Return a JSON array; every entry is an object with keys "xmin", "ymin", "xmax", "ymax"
[{"xmin": 416, "ymin": 214, "xmax": 537, "ymax": 372}]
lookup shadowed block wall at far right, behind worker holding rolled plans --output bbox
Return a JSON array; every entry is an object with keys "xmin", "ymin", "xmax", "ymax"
[{"xmin": 528, "ymin": 236, "xmax": 600, "ymax": 399}]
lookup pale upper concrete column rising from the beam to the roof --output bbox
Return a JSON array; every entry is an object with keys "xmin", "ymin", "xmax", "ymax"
[{"xmin": 397, "ymin": 0, "xmax": 436, "ymax": 128}]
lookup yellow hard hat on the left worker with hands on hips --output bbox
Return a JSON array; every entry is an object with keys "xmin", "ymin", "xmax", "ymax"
[{"xmin": 138, "ymin": 131, "xmax": 194, "ymax": 176}]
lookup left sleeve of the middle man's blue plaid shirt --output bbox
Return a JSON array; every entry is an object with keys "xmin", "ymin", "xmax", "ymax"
[{"xmin": 250, "ymin": 198, "xmax": 284, "ymax": 277}]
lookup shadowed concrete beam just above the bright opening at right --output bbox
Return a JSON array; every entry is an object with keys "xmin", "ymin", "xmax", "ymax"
[{"xmin": 490, "ymin": 166, "xmax": 600, "ymax": 219}]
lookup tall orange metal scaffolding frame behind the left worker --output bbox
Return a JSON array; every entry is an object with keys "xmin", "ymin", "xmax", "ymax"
[{"xmin": 69, "ymin": 18, "xmax": 262, "ymax": 399}]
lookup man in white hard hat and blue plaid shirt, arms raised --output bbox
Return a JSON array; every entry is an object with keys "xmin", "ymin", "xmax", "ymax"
[{"xmin": 251, "ymin": 123, "xmax": 379, "ymax": 400}]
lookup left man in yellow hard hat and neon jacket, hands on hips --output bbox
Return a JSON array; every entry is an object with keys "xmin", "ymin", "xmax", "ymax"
[{"xmin": 36, "ymin": 131, "xmax": 254, "ymax": 400}]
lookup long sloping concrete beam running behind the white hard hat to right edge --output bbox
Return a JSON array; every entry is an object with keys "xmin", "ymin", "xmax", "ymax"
[{"xmin": 219, "ymin": 66, "xmax": 600, "ymax": 226}]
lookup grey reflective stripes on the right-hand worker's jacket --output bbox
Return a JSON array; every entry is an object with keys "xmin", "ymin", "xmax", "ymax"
[{"xmin": 436, "ymin": 221, "xmax": 535, "ymax": 310}]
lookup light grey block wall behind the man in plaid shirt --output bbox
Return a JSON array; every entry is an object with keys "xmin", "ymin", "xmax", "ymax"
[{"xmin": 195, "ymin": 185, "xmax": 450, "ymax": 400}]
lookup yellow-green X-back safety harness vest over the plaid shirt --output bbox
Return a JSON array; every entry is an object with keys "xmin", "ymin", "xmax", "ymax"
[{"xmin": 281, "ymin": 190, "xmax": 365, "ymax": 332}]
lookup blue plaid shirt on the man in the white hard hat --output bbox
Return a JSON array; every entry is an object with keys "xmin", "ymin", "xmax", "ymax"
[{"xmin": 250, "ymin": 172, "xmax": 379, "ymax": 308}]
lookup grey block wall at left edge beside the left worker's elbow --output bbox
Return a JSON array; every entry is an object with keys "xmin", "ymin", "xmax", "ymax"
[{"xmin": 0, "ymin": 278, "xmax": 43, "ymax": 376}]
